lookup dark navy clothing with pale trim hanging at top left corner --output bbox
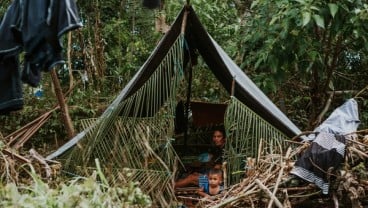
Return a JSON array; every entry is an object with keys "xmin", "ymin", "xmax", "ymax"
[{"xmin": 0, "ymin": 0, "xmax": 82, "ymax": 114}]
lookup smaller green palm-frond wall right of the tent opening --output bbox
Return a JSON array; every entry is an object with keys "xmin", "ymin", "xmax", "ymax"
[{"xmin": 224, "ymin": 96, "xmax": 288, "ymax": 184}]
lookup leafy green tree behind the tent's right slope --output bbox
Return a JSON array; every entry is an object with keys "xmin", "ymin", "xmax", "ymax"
[{"xmin": 242, "ymin": 0, "xmax": 368, "ymax": 128}]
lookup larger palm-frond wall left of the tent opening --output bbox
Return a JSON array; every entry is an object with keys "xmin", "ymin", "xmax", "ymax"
[{"xmin": 65, "ymin": 36, "xmax": 184, "ymax": 207}]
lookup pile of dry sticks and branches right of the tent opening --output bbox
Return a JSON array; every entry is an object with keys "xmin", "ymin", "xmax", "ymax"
[{"xmin": 195, "ymin": 131, "xmax": 368, "ymax": 207}]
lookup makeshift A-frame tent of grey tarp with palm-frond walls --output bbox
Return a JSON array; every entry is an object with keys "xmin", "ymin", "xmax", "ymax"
[{"xmin": 47, "ymin": 5, "xmax": 300, "ymax": 206}]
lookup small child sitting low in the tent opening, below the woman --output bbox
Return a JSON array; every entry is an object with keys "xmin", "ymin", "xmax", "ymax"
[{"xmin": 198, "ymin": 169, "xmax": 223, "ymax": 197}]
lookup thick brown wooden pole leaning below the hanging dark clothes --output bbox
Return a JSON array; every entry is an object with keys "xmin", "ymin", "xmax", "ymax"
[{"xmin": 51, "ymin": 69, "xmax": 75, "ymax": 138}]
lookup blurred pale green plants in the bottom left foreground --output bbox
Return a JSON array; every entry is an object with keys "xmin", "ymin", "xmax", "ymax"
[{"xmin": 0, "ymin": 166, "xmax": 151, "ymax": 207}]
